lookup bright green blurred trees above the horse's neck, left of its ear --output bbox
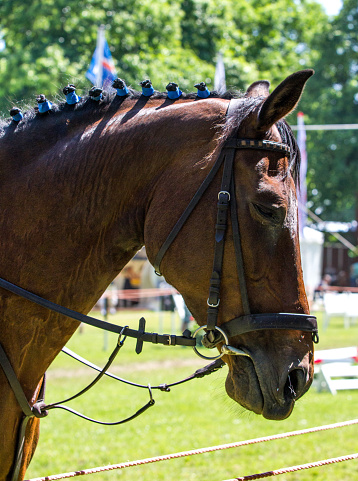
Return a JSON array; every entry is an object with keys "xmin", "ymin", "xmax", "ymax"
[{"xmin": 0, "ymin": 0, "xmax": 327, "ymax": 115}]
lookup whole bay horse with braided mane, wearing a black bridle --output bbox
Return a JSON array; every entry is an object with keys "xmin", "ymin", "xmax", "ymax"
[{"xmin": 0, "ymin": 70, "xmax": 313, "ymax": 481}]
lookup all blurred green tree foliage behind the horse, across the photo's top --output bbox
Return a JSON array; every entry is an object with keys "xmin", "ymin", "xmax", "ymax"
[{"xmin": 0, "ymin": 0, "xmax": 358, "ymax": 220}]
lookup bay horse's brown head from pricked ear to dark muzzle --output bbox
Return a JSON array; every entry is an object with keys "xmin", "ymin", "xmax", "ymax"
[{"xmin": 145, "ymin": 70, "xmax": 313, "ymax": 419}]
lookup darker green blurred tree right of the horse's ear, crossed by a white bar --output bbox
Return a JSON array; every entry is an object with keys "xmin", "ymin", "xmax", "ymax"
[{"xmin": 300, "ymin": 0, "xmax": 358, "ymax": 221}]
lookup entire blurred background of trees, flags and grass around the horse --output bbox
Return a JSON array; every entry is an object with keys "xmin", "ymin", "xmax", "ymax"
[{"xmin": 0, "ymin": 0, "xmax": 358, "ymax": 481}]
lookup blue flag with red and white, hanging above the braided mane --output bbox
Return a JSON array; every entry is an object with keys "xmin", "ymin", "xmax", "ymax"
[{"xmin": 86, "ymin": 26, "xmax": 117, "ymax": 87}]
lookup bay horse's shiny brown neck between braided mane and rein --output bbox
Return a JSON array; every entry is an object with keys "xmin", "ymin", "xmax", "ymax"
[{"xmin": 0, "ymin": 100, "xmax": 227, "ymax": 311}]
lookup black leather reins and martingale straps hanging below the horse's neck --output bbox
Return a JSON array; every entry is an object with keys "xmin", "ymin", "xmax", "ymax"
[{"xmin": 0, "ymin": 278, "xmax": 225, "ymax": 481}]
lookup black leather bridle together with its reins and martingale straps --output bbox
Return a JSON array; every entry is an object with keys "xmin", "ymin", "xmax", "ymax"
[{"xmin": 0, "ymin": 99, "xmax": 318, "ymax": 481}]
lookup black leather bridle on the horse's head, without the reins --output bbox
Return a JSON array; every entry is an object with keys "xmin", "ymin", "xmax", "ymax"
[{"xmin": 154, "ymin": 99, "xmax": 319, "ymax": 359}]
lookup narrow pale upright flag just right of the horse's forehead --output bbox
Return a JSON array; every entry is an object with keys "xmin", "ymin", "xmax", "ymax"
[{"xmin": 297, "ymin": 112, "xmax": 307, "ymax": 235}]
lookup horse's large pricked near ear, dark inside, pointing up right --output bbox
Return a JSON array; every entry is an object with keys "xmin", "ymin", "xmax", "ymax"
[{"xmin": 257, "ymin": 69, "xmax": 314, "ymax": 131}]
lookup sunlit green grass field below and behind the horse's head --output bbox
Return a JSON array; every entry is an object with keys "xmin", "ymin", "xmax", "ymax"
[{"xmin": 27, "ymin": 311, "xmax": 358, "ymax": 481}]
